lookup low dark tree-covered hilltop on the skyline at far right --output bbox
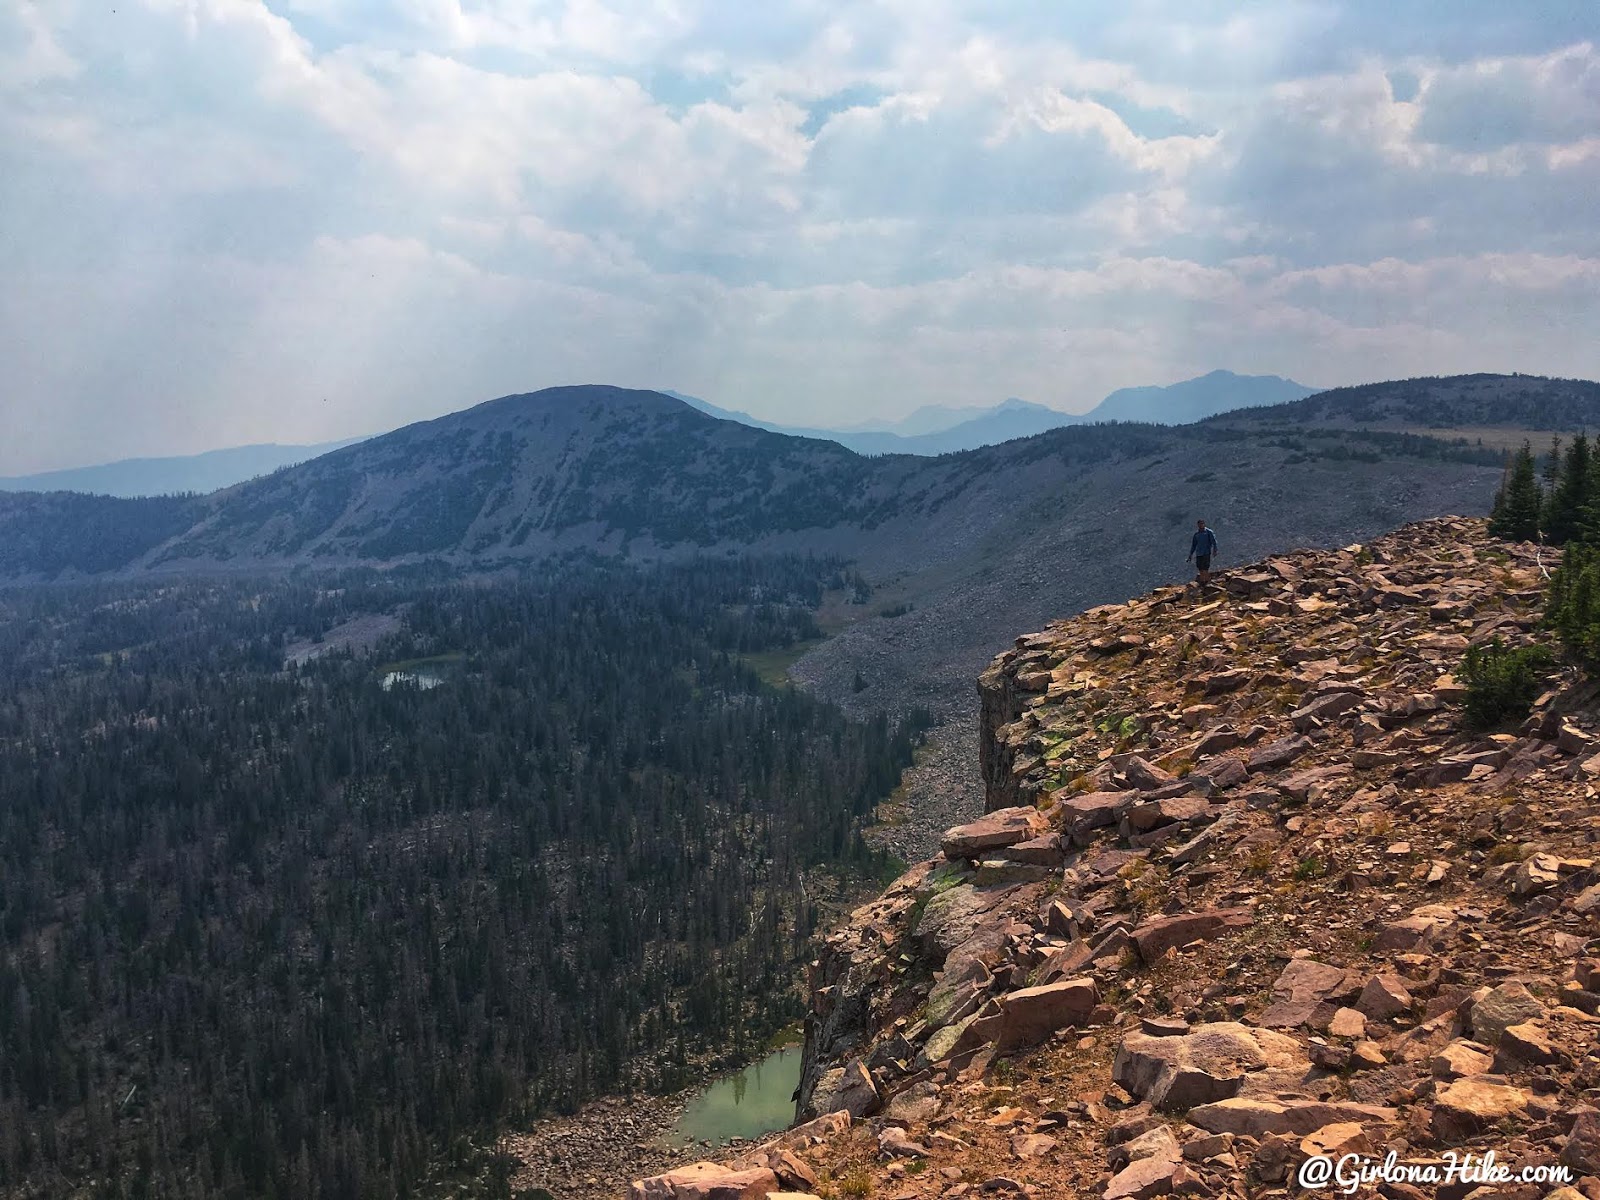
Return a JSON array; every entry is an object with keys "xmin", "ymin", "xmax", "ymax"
[{"xmin": 1211, "ymin": 374, "xmax": 1600, "ymax": 443}]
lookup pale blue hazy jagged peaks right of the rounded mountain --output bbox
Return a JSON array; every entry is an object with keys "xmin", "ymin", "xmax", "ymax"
[{"xmin": 662, "ymin": 371, "xmax": 1317, "ymax": 456}]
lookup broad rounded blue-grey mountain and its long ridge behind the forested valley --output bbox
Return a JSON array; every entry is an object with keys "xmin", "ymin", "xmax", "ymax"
[{"xmin": 0, "ymin": 377, "xmax": 1494, "ymax": 579}]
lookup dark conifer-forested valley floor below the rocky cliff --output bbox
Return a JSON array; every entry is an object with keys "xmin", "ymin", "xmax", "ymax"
[{"xmin": 0, "ymin": 557, "xmax": 926, "ymax": 1197}]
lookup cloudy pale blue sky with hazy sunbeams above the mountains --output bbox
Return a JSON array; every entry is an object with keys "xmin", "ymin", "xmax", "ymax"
[{"xmin": 0, "ymin": 0, "xmax": 1600, "ymax": 474}]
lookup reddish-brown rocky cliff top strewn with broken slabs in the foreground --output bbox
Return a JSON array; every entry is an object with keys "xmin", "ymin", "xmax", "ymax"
[{"xmin": 634, "ymin": 518, "xmax": 1600, "ymax": 1200}]
